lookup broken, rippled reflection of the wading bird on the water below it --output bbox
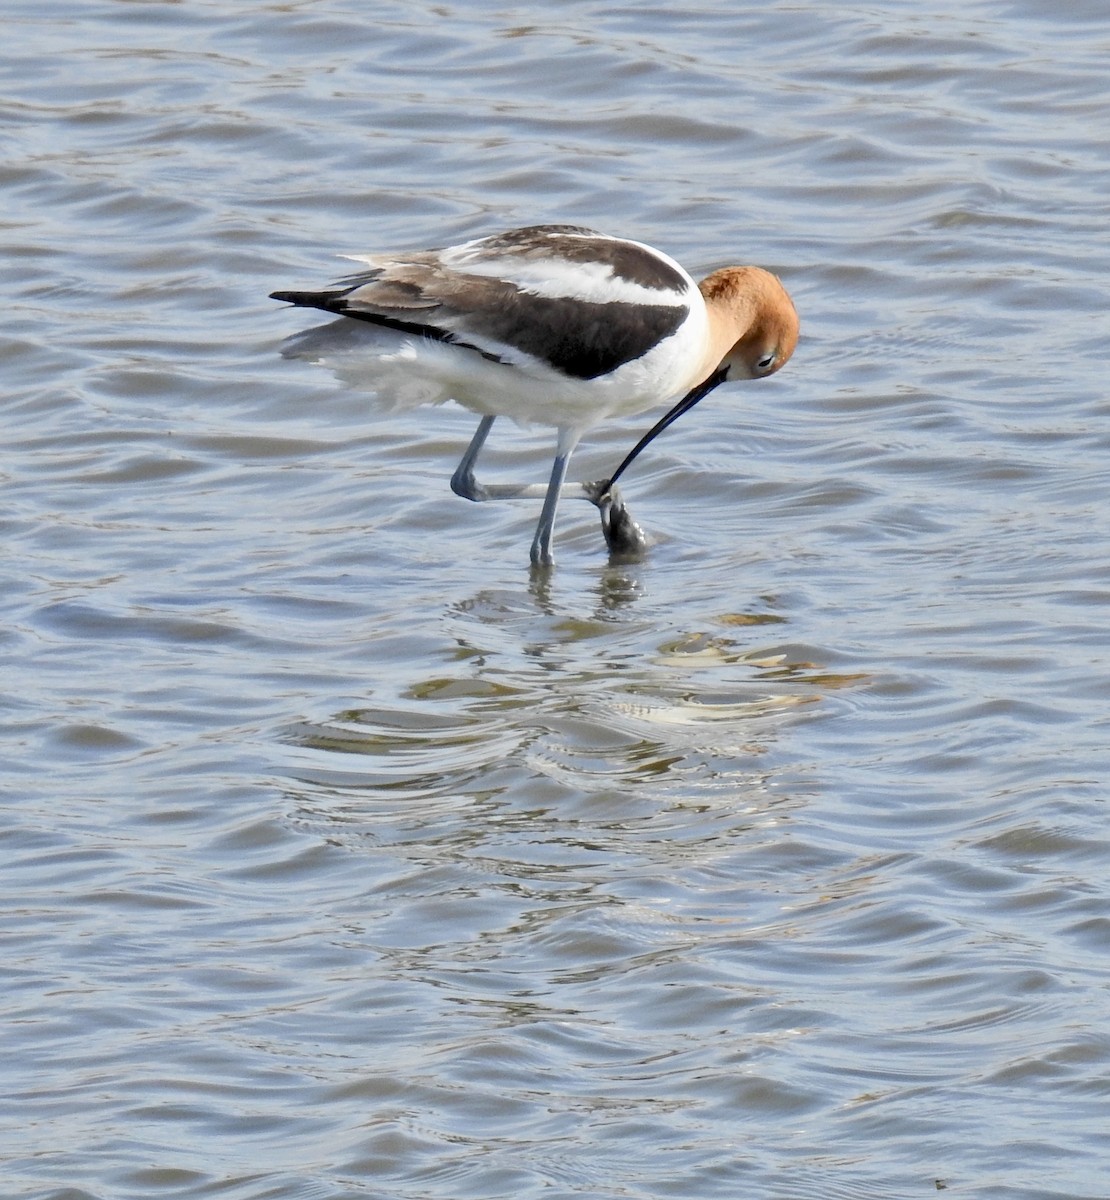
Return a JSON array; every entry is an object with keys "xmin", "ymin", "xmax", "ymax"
[{"xmin": 272, "ymin": 549, "xmax": 864, "ymax": 836}]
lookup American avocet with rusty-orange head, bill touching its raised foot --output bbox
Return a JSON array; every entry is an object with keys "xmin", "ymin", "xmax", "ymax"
[{"xmin": 272, "ymin": 226, "xmax": 798, "ymax": 565}]
